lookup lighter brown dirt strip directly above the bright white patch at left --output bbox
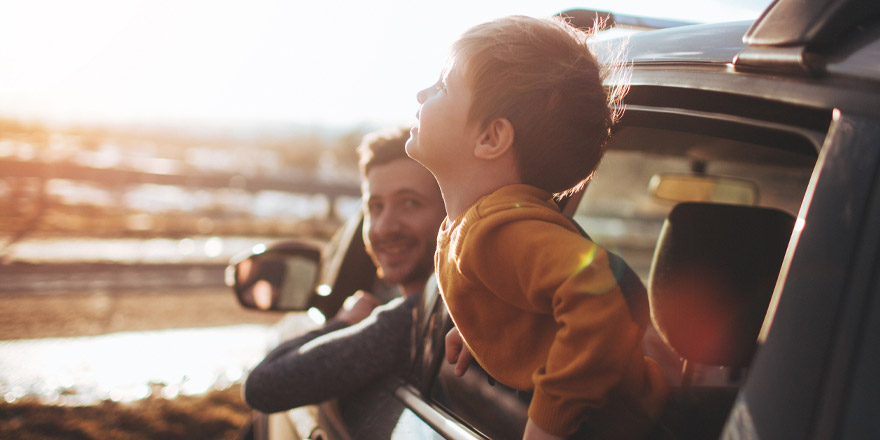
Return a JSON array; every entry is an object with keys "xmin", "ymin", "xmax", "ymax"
[{"xmin": 0, "ymin": 288, "xmax": 282, "ymax": 340}]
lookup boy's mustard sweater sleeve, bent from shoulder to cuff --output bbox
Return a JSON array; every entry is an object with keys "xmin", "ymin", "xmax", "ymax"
[{"xmin": 462, "ymin": 221, "xmax": 641, "ymax": 435}]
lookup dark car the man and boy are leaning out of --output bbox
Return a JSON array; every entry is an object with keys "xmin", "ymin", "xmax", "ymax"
[{"xmin": 230, "ymin": 0, "xmax": 880, "ymax": 439}]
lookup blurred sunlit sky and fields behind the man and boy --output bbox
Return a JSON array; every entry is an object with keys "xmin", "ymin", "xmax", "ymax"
[{"xmin": 0, "ymin": 0, "xmax": 769, "ymax": 438}]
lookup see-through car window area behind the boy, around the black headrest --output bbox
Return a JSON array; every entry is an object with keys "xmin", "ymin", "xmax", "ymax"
[{"xmin": 573, "ymin": 126, "xmax": 818, "ymax": 385}]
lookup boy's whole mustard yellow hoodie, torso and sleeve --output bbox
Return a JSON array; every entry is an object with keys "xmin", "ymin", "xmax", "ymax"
[{"xmin": 434, "ymin": 185, "xmax": 669, "ymax": 438}]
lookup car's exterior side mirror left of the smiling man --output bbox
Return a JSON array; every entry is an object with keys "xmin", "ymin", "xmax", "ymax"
[{"xmin": 226, "ymin": 240, "xmax": 321, "ymax": 311}]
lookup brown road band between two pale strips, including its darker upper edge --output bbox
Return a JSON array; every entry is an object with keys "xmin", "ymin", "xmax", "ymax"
[{"xmin": 0, "ymin": 265, "xmax": 283, "ymax": 340}]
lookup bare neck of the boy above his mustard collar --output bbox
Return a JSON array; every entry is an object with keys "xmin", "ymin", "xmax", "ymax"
[{"xmin": 437, "ymin": 165, "xmax": 522, "ymax": 221}]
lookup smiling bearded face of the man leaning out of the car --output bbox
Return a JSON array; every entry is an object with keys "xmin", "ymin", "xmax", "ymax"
[{"xmin": 361, "ymin": 158, "xmax": 446, "ymax": 294}]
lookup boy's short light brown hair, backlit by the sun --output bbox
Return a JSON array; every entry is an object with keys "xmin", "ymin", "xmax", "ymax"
[{"xmin": 447, "ymin": 16, "xmax": 625, "ymax": 196}]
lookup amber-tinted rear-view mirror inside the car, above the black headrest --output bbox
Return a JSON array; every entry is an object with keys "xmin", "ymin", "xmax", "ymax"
[{"xmin": 648, "ymin": 174, "xmax": 758, "ymax": 206}]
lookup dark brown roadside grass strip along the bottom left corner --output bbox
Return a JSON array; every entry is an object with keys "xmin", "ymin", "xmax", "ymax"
[{"xmin": 0, "ymin": 385, "xmax": 250, "ymax": 440}]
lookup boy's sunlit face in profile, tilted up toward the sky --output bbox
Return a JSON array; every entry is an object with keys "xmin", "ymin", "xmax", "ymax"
[{"xmin": 406, "ymin": 66, "xmax": 477, "ymax": 179}]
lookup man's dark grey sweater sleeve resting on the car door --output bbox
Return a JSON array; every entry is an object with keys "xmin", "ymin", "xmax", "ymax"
[{"xmin": 243, "ymin": 295, "xmax": 420, "ymax": 413}]
